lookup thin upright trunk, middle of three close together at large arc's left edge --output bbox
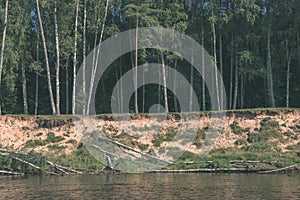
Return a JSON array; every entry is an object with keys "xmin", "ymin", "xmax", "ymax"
[{"xmin": 82, "ymin": 0, "xmax": 86, "ymax": 115}]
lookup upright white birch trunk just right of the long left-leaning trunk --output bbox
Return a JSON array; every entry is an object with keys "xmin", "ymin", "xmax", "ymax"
[{"xmin": 54, "ymin": 1, "xmax": 60, "ymax": 115}]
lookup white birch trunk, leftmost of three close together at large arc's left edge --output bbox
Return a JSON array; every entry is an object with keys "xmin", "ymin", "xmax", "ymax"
[{"xmin": 72, "ymin": 0, "xmax": 79, "ymax": 115}]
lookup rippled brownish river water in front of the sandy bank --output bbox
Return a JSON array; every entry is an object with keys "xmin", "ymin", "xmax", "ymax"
[{"xmin": 0, "ymin": 174, "xmax": 300, "ymax": 200}]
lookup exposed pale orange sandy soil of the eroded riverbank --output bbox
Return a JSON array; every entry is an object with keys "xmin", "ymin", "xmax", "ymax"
[{"xmin": 0, "ymin": 110, "xmax": 300, "ymax": 153}]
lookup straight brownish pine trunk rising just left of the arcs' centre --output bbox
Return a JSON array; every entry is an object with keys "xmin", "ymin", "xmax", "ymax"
[{"xmin": 134, "ymin": 15, "xmax": 139, "ymax": 113}]
